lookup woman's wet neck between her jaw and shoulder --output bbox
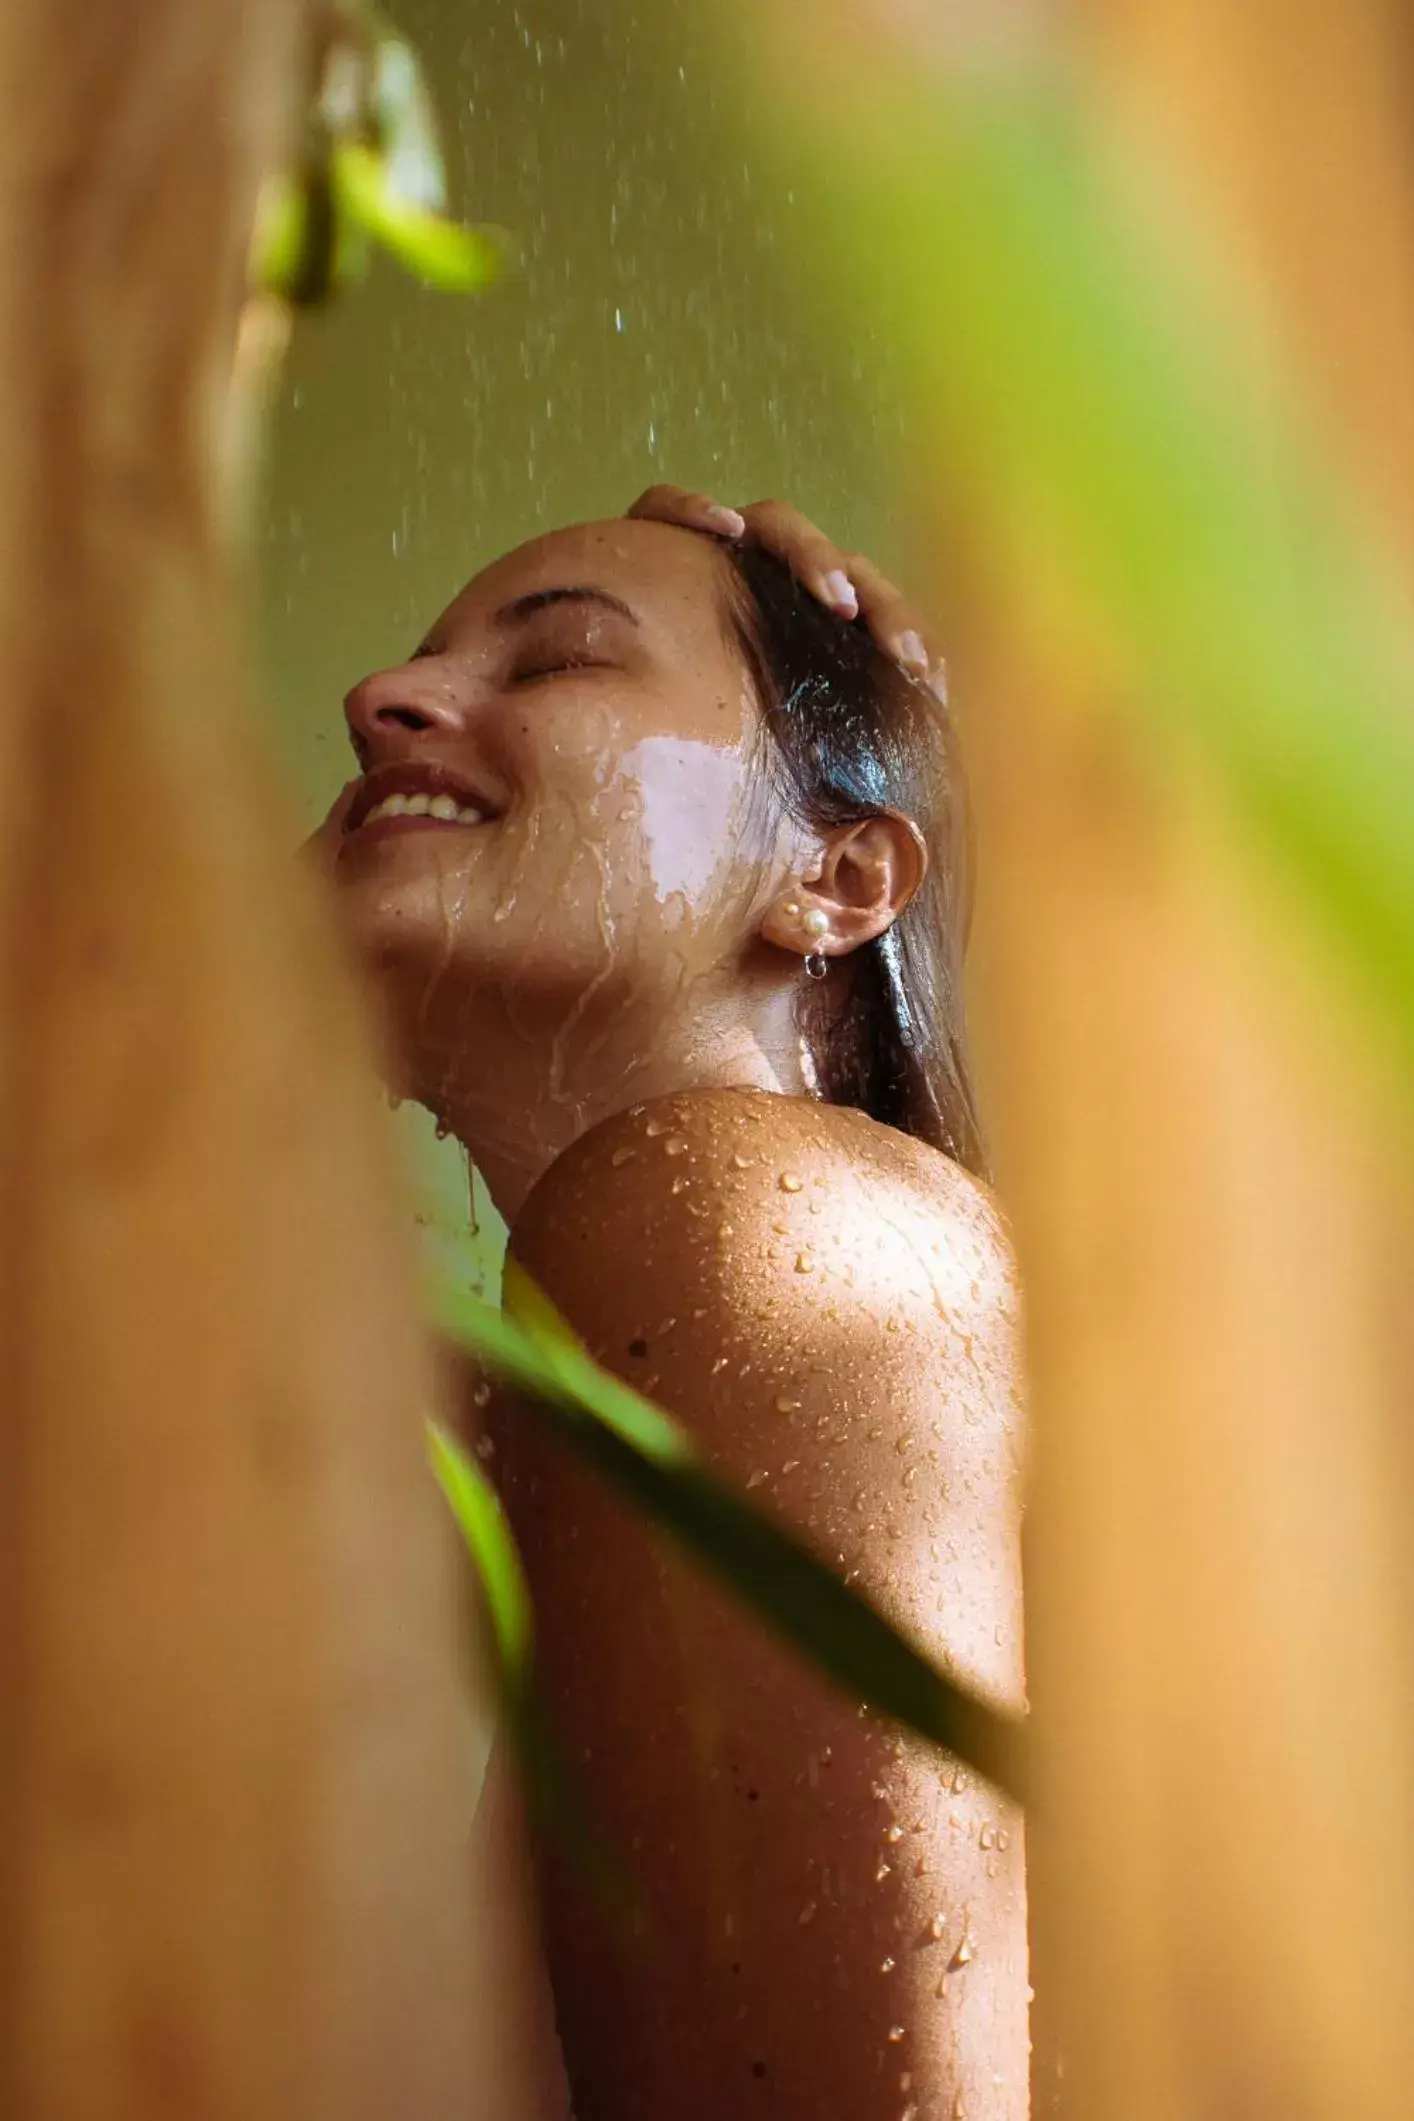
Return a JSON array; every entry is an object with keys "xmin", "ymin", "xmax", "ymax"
[{"xmin": 409, "ymin": 991, "xmax": 808, "ymax": 1228}]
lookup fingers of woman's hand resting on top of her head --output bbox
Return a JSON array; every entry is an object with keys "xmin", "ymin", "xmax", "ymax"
[{"xmin": 628, "ymin": 486, "xmax": 948, "ymax": 702}]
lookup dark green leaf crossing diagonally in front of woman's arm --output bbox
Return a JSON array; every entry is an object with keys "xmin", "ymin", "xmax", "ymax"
[{"xmin": 435, "ymin": 1268, "xmax": 1024, "ymax": 1796}]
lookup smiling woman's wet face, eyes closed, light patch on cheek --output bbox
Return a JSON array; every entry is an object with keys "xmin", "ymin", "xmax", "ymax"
[{"xmin": 337, "ymin": 522, "xmax": 784, "ymax": 1103}]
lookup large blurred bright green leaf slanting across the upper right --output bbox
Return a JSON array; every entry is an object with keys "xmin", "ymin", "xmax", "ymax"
[{"xmin": 767, "ymin": 68, "xmax": 1414, "ymax": 1061}]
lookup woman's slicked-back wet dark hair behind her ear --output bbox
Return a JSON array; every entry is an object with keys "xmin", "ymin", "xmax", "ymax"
[{"xmin": 723, "ymin": 545, "xmax": 986, "ymax": 1177}]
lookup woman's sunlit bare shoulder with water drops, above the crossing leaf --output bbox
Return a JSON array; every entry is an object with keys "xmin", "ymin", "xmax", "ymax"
[{"xmin": 513, "ymin": 1090, "xmax": 1022, "ymax": 1697}]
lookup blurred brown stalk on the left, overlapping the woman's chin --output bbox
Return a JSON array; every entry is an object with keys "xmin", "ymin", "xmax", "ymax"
[{"xmin": 0, "ymin": 0, "xmax": 502, "ymax": 2121}]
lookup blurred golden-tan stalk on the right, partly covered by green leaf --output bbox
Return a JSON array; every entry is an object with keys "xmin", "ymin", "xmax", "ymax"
[{"xmin": 737, "ymin": 0, "xmax": 1414, "ymax": 2121}]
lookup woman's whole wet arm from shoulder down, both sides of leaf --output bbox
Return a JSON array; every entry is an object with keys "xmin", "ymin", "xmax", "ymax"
[{"xmin": 498, "ymin": 1101, "xmax": 1026, "ymax": 2121}]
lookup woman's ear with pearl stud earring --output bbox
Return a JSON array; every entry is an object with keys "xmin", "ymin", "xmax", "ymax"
[{"xmin": 761, "ymin": 810, "xmax": 929, "ymax": 957}]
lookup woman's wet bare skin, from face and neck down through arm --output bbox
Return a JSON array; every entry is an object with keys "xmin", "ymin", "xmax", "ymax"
[{"xmin": 335, "ymin": 522, "xmax": 1026, "ymax": 2121}]
